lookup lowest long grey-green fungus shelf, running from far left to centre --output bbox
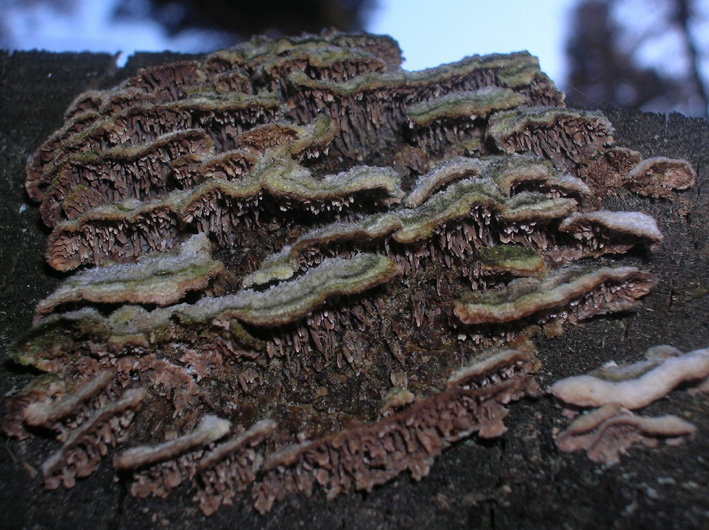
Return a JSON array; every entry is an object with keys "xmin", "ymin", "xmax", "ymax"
[{"xmin": 16, "ymin": 254, "xmax": 401, "ymax": 376}]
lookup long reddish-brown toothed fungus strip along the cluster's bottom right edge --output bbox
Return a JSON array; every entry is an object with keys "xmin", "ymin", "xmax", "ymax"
[{"xmin": 254, "ymin": 344, "xmax": 537, "ymax": 513}]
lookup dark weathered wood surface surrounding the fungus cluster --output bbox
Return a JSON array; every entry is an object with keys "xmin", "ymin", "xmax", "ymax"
[{"xmin": 0, "ymin": 52, "xmax": 709, "ymax": 528}]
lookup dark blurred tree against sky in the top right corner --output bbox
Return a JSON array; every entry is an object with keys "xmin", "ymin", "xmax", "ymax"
[{"xmin": 565, "ymin": 0, "xmax": 709, "ymax": 116}]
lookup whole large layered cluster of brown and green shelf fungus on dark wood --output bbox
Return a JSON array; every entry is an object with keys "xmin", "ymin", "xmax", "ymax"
[{"xmin": 4, "ymin": 34, "xmax": 694, "ymax": 514}]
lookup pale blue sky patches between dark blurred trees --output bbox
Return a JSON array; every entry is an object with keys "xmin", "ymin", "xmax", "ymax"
[{"xmin": 0, "ymin": 0, "xmax": 573, "ymax": 83}]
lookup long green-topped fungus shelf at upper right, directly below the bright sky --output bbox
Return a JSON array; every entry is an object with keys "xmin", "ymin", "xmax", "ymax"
[{"xmin": 288, "ymin": 52, "xmax": 561, "ymax": 157}]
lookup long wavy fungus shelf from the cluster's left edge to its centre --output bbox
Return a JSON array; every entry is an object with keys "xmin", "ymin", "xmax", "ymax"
[{"xmin": 47, "ymin": 160, "xmax": 401, "ymax": 271}]
